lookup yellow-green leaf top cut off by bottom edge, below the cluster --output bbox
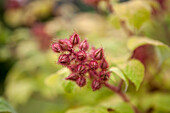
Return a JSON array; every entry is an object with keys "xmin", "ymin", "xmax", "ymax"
[{"xmin": 66, "ymin": 106, "xmax": 108, "ymax": 113}]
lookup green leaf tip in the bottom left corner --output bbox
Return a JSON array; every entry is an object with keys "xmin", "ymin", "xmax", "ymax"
[{"xmin": 0, "ymin": 98, "xmax": 16, "ymax": 113}]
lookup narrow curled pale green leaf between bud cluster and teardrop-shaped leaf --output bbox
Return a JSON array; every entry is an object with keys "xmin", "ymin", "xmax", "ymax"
[{"xmin": 109, "ymin": 67, "xmax": 129, "ymax": 91}]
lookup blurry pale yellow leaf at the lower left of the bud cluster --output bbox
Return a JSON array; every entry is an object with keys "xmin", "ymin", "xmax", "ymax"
[{"xmin": 45, "ymin": 68, "xmax": 69, "ymax": 87}]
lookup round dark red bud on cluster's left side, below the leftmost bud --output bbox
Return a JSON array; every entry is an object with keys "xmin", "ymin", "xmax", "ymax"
[{"xmin": 58, "ymin": 54, "xmax": 70, "ymax": 65}]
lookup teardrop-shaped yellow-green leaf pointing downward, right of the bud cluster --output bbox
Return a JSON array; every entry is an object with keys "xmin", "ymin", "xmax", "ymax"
[{"xmin": 124, "ymin": 59, "xmax": 144, "ymax": 90}]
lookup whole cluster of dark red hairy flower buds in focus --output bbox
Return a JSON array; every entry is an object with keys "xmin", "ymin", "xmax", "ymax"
[{"xmin": 51, "ymin": 33, "xmax": 110, "ymax": 91}]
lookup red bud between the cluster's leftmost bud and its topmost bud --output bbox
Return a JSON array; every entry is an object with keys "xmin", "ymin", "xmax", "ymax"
[{"xmin": 58, "ymin": 39, "xmax": 72, "ymax": 51}]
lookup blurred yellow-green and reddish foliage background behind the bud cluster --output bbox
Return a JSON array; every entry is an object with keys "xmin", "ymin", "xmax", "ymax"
[{"xmin": 0, "ymin": 0, "xmax": 170, "ymax": 113}]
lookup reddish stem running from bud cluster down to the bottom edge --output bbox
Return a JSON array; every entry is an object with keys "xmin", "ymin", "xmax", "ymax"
[{"xmin": 104, "ymin": 82, "xmax": 140, "ymax": 113}]
